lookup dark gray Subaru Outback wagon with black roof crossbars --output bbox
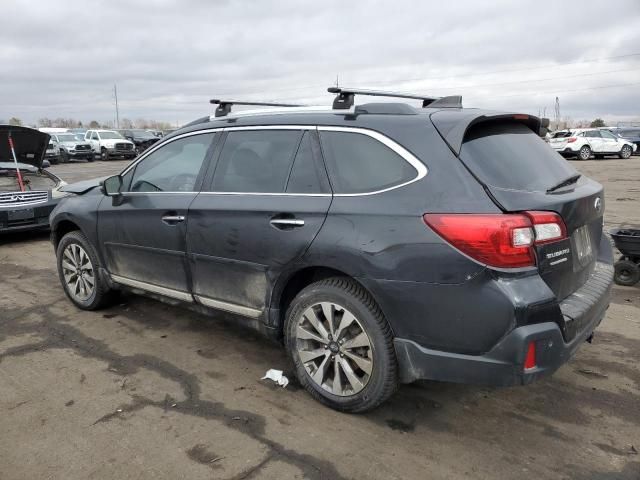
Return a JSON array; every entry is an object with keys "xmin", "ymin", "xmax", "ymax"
[{"xmin": 51, "ymin": 89, "xmax": 613, "ymax": 412}]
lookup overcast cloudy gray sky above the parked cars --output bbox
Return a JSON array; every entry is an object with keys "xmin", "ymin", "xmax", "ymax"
[{"xmin": 0, "ymin": 0, "xmax": 640, "ymax": 124}]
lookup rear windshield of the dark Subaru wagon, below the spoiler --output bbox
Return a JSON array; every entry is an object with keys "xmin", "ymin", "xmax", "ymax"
[{"xmin": 460, "ymin": 122, "xmax": 577, "ymax": 192}]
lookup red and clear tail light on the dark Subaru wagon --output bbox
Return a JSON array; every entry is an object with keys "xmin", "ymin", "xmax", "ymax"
[{"xmin": 423, "ymin": 212, "xmax": 566, "ymax": 268}]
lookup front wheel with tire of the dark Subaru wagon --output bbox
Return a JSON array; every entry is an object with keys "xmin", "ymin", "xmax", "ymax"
[{"xmin": 56, "ymin": 230, "xmax": 116, "ymax": 310}]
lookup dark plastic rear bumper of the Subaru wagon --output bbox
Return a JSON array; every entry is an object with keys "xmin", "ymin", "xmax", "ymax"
[{"xmin": 394, "ymin": 262, "xmax": 613, "ymax": 386}]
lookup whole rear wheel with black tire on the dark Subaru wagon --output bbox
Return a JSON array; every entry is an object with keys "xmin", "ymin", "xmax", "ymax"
[{"xmin": 284, "ymin": 277, "xmax": 398, "ymax": 413}]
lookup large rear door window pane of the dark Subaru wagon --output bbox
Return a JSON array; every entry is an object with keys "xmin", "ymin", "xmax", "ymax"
[{"xmin": 212, "ymin": 130, "xmax": 302, "ymax": 193}]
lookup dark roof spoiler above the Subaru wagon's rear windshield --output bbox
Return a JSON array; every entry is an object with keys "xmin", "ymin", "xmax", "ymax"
[{"xmin": 429, "ymin": 109, "xmax": 542, "ymax": 155}]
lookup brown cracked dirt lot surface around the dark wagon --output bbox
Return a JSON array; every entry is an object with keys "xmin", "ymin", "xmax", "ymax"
[{"xmin": 0, "ymin": 157, "xmax": 640, "ymax": 480}]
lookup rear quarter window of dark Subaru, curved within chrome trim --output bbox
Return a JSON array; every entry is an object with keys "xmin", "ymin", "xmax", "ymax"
[{"xmin": 320, "ymin": 132, "xmax": 417, "ymax": 193}]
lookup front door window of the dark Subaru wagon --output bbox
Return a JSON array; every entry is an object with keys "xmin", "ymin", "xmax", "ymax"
[{"xmin": 130, "ymin": 133, "xmax": 214, "ymax": 192}]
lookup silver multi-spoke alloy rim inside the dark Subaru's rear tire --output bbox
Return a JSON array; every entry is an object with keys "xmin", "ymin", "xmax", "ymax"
[{"xmin": 295, "ymin": 302, "xmax": 373, "ymax": 397}]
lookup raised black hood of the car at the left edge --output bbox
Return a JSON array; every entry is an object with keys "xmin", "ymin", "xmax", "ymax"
[{"xmin": 0, "ymin": 125, "xmax": 51, "ymax": 169}]
